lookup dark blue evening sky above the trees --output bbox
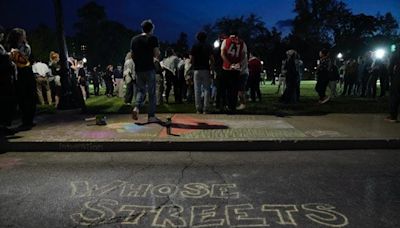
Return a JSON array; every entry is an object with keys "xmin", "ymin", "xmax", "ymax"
[{"xmin": 0, "ymin": 0, "xmax": 400, "ymax": 41}]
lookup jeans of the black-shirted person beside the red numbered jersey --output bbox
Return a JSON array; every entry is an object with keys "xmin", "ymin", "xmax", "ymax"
[{"xmin": 194, "ymin": 70, "xmax": 211, "ymax": 112}]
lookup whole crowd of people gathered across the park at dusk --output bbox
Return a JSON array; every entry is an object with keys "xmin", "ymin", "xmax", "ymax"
[{"xmin": 0, "ymin": 20, "xmax": 400, "ymax": 134}]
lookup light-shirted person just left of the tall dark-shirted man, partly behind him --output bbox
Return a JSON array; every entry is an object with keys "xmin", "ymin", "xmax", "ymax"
[{"xmin": 123, "ymin": 52, "xmax": 136, "ymax": 105}]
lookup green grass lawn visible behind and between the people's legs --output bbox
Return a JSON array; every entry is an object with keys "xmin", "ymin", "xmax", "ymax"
[{"xmin": 39, "ymin": 81, "xmax": 388, "ymax": 115}]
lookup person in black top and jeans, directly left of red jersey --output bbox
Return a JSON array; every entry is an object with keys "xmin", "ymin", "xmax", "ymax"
[{"xmin": 190, "ymin": 32, "xmax": 214, "ymax": 114}]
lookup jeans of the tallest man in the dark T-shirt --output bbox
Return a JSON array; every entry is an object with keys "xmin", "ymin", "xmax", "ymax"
[{"xmin": 136, "ymin": 70, "xmax": 156, "ymax": 117}]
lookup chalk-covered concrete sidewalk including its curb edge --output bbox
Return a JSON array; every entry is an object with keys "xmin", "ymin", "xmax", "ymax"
[{"xmin": 1, "ymin": 111, "xmax": 400, "ymax": 151}]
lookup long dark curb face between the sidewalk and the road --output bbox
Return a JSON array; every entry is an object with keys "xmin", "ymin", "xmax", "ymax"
[{"xmin": 0, "ymin": 139, "xmax": 400, "ymax": 152}]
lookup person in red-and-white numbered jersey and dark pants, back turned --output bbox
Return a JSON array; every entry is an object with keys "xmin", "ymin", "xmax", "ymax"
[{"xmin": 221, "ymin": 31, "xmax": 247, "ymax": 113}]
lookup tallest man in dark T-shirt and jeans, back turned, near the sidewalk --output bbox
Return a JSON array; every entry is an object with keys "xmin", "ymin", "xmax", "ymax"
[{"xmin": 131, "ymin": 20, "xmax": 160, "ymax": 123}]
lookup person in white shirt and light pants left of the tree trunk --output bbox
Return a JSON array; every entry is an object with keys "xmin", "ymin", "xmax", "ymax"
[{"xmin": 32, "ymin": 61, "xmax": 53, "ymax": 105}]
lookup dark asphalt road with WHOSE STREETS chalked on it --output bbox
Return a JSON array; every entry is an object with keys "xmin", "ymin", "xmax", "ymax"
[{"xmin": 0, "ymin": 150, "xmax": 400, "ymax": 228}]
